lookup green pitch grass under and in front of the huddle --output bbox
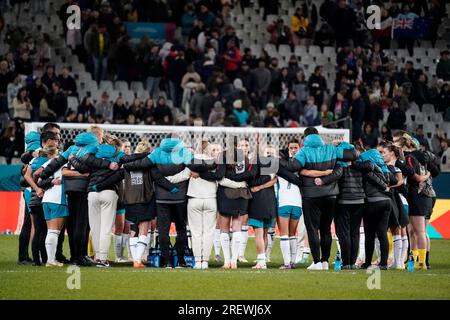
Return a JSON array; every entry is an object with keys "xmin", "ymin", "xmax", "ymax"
[{"xmin": 0, "ymin": 236, "xmax": 450, "ymax": 300}]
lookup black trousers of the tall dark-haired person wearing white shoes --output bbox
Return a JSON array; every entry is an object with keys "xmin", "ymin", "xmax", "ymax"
[{"xmin": 303, "ymin": 198, "xmax": 336, "ymax": 263}]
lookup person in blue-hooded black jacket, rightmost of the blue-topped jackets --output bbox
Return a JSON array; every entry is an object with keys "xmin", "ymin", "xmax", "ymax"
[{"xmin": 358, "ymin": 149, "xmax": 398, "ymax": 270}]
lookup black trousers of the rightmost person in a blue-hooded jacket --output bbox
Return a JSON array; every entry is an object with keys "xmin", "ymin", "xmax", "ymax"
[{"xmin": 363, "ymin": 200, "xmax": 391, "ymax": 266}]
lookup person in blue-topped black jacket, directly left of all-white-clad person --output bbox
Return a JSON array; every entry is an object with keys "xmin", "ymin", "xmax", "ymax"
[{"xmin": 121, "ymin": 137, "xmax": 209, "ymax": 269}]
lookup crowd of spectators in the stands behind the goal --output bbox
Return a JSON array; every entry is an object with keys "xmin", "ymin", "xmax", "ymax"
[{"xmin": 0, "ymin": 0, "xmax": 450, "ymax": 170}]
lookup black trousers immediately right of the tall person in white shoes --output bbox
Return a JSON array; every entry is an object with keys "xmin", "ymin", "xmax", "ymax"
[{"xmin": 334, "ymin": 203, "xmax": 364, "ymax": 266}]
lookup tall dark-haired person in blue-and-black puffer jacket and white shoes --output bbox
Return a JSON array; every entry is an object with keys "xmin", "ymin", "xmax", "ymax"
[{"xmin": 280, "ymin": 127, "xmax": 358, "ymax": 270}]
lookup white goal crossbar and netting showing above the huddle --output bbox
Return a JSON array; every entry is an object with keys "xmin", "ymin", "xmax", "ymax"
[{"xmin": 25, "ymin": 122, "xmax": 350, "ymax": 149}]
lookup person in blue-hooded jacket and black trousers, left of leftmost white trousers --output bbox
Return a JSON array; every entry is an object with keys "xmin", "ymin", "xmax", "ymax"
[{"xmin": 41, "ymin": 132, "xmax": 99, "ymax": 266}]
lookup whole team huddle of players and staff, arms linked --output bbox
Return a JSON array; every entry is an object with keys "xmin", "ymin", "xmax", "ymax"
[{"xmin": 19, "ymin": 123, "xmax": 439, "ymax": 270}]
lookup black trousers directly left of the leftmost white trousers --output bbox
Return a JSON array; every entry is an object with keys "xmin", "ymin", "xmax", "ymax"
[{"xmin": 67, "ymin": 191, "xmax": 89, "ymax": 261}]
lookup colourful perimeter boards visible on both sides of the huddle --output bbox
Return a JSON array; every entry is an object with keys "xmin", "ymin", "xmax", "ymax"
[{"xmin": 0, "ymin": 165, "xmax": 450, "ymax": 239}]
